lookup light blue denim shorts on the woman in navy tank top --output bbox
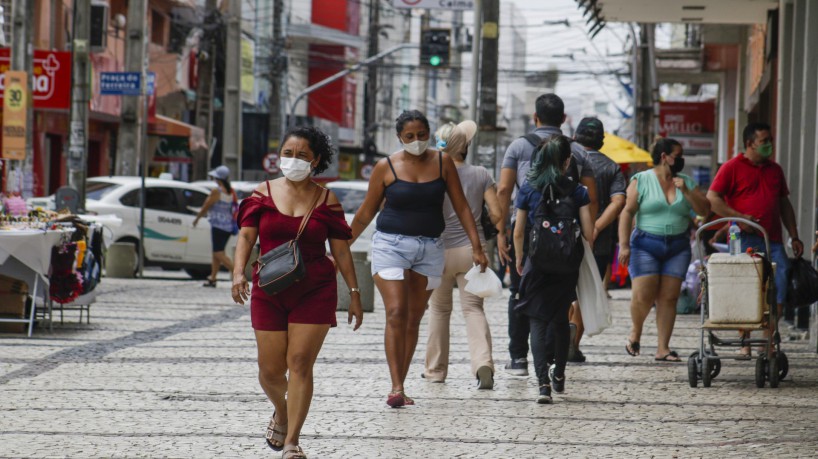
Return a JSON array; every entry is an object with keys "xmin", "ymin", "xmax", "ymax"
[{"xmin": 372, "ymin": 231, "xmax": 445, "ymax": 279}]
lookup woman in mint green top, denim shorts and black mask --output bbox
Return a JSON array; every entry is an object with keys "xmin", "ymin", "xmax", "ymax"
[{"xmin": 619, "ymin": 138, "xmax": 710, "ymax": 362}]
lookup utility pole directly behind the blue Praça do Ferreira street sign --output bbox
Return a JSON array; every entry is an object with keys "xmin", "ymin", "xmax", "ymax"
[{"xmin": 116, "ymin": 0, "xmax": 148, "ymax": 175}]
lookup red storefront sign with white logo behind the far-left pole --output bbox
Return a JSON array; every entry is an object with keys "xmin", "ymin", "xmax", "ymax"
[{"xmin": 0, "ymin": 48, "xmax": 71, "ymax": 109}]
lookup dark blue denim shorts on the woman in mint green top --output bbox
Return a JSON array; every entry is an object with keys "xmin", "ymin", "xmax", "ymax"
[{"xmin": 628, "ymin": 228, "xmax": 691, "ymax": 279}]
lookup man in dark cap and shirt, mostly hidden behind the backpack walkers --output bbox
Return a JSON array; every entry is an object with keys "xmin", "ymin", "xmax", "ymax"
[{"xmin": 568, "ymin": 118, "xmax": 628, "ymax": 362}]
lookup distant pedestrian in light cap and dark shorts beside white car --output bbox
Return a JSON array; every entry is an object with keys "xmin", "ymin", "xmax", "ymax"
[{"xmin": 193, "ymin": 166, "xmax": 238, "ymax": 287}]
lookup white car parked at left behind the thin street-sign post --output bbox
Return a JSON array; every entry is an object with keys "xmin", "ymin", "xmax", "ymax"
[{"xmin": 75, "ymin": 177, "xmax": 228, "ymax": 279}]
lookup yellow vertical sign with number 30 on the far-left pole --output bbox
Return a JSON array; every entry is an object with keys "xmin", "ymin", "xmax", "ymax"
[{"xmin": 3, "ymin": 71, "xmax": 28, "ymax": 160}]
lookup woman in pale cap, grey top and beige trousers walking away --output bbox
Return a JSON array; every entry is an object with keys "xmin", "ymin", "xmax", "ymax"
[{"xmin": 423, "ymin": 120, "xmax": 500, "ymax": 389}]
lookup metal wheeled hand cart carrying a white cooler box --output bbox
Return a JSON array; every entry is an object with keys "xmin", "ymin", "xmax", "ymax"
[{"xmin": 687, "ymin": 218, "xmax": 789, "ymax": 388}]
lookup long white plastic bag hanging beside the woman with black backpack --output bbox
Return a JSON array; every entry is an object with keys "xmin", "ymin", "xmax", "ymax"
[{"xmin": 577, "ymin": 238, "xmax": 611, "ymax": 336}]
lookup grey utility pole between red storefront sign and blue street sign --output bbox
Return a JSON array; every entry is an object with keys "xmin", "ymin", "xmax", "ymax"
[{"xmin": 68, "ymin": 0, "xmax": 91, "ymax": 210}]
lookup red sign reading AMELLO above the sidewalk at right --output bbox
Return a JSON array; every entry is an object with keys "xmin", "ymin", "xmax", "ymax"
[{"xmin": 659, "ymin": 101, "xmax": 716, "ymax": 155}]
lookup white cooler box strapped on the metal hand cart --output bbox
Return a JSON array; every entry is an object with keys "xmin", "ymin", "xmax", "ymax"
[{"xmin": 707, "ymin": 253, "xmax": 764, "ymax": 324}]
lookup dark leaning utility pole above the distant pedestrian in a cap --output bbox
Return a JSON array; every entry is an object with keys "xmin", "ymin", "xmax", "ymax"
[{"xmin": 194, "ymin": 0, "xmax": 219, "ymax": 158}]
